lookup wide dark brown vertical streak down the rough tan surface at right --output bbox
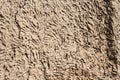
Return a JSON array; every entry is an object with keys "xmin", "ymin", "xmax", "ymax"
[{"xmin": 104, "ymin": 0, "xmax": 118, "ymax": 76}]
